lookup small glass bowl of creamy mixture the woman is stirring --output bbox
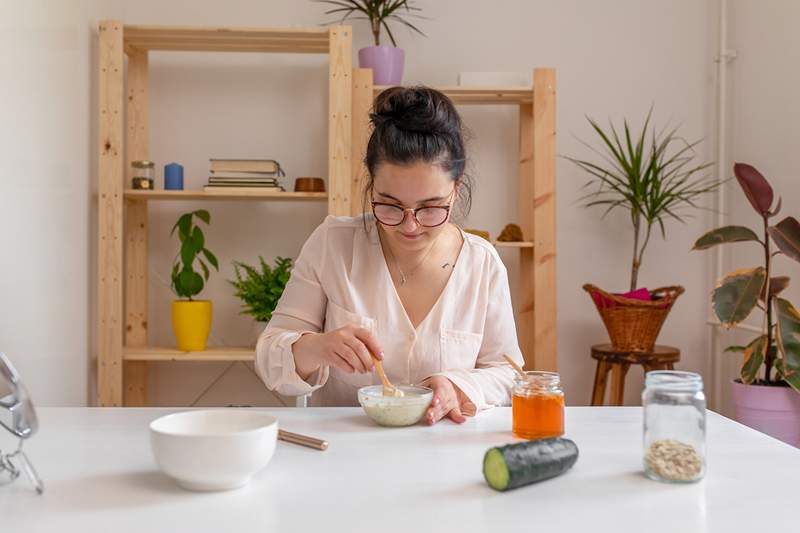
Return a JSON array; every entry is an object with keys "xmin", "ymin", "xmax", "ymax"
[{"xmin": 358, "ymin": 385, "xmax": 433, "ymax": 427}]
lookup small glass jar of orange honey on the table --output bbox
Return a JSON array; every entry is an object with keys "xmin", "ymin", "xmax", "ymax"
[{"xmin": 511, "ymin": 371, "xmax": 564, "ymax": 439}]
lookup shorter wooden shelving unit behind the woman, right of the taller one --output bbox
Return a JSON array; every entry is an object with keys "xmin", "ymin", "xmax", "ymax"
[{"xmin": 351, "ymin": 68, "xmax": 557, "ymax": 370}]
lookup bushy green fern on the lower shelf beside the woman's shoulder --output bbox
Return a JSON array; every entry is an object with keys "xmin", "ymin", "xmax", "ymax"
[{"xmin": 228, "ymin": 256, "xmax": 292, "ymax": 333}]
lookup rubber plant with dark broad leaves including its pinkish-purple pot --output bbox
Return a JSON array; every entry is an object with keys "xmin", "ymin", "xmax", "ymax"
[{"xmin": 693, "ymin": 163, "xmax": 800, "ymax": 446}]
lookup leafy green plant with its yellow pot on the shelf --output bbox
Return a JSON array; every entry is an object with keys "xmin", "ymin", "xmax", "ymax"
[{"xmin": 170, "ymin": 209, "xmax": 219, "ymax": 352}]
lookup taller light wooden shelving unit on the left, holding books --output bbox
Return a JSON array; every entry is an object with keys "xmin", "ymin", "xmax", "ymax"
[{"xmin": 97, "ymin": 21, "xmax": 353, "ymax": 406}]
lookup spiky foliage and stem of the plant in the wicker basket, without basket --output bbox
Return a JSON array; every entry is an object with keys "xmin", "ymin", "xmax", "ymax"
[{"xmin": 566, "ymin": 109, "xmax": 720, "ymax": 291}]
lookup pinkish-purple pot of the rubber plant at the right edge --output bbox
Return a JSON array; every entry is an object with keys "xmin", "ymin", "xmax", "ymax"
[{"xmin": 733, "ymin": 381, "xmax": 800, "ymax": 448}]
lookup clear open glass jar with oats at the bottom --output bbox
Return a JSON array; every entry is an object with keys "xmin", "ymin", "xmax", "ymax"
[{"xmin": 642, "ymin": 370, "xmax": 706, "ymax": 483}]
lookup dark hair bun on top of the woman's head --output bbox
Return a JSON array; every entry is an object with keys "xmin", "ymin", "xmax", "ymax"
[{"xmin": 370, "ymin": 87, "xmax": 461, "ymax": 135}]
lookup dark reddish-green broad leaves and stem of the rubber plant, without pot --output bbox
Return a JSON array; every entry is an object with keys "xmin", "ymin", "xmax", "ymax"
[{"xmin": 693, "ymin": 163, "xmax": 800, "ymax": 391}]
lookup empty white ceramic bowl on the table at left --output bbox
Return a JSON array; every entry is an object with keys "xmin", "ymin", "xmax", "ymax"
[{"xmin": 150, "ymin": 409, "xmax": 278, "ymax": 491}]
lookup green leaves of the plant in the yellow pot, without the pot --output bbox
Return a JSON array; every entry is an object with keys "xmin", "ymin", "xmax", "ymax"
[{"xmin": 170, "ymin": 209, "xmax": 219, "ymax": 301}]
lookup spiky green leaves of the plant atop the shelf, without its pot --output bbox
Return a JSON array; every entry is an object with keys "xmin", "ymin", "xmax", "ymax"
[{"xmin": 315, "ymin": 0, "xmax": 425, "ymax": 46}]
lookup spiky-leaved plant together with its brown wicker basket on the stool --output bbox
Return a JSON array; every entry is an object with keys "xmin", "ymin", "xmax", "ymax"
[{"xmin": 566, "ymin": 109, "xmax": 719, "ymax": 352}]
